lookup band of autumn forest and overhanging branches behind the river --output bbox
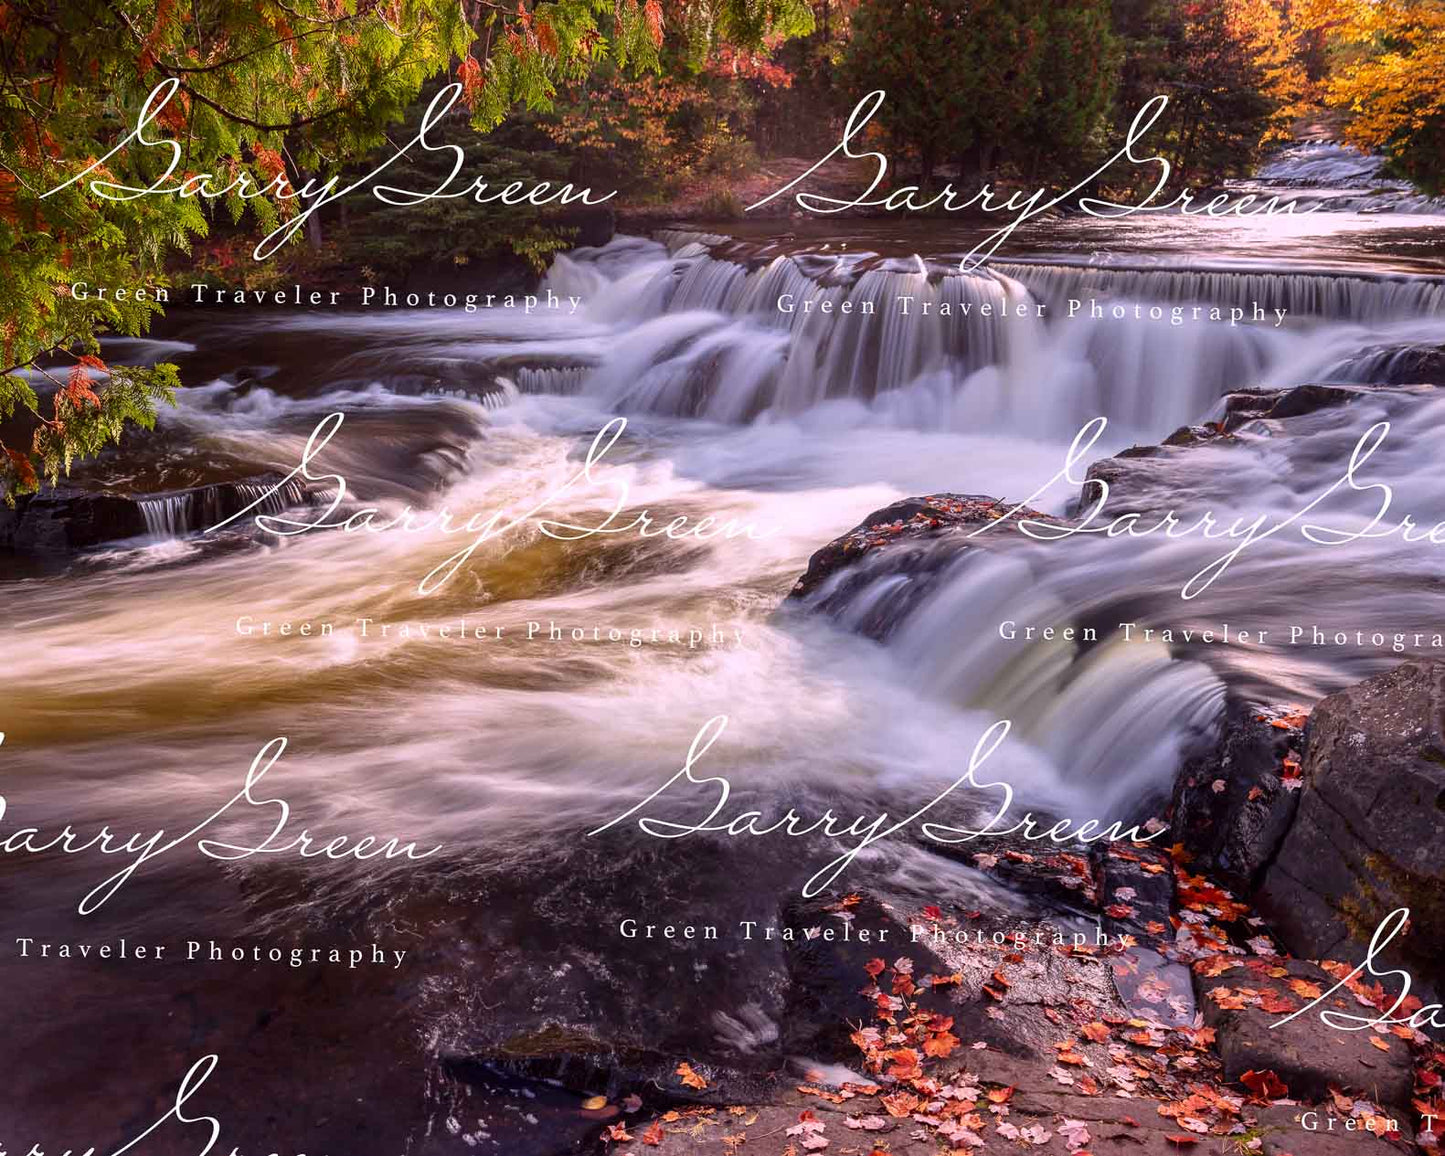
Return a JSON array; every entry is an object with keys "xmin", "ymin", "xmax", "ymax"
[{"xmin": 0, "ymin": 0, "xmax": 1445, "ymax": 501}]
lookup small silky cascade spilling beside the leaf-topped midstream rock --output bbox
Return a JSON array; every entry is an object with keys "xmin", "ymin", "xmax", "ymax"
[{"xmin": 808, "ymin": 549, "xmax": 1225, "ymax": 816}]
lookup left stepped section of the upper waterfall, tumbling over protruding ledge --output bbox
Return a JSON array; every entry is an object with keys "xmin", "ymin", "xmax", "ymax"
[{"xmin": 585, "ymin": 243, "xmax": 1036, "ymax": 422}]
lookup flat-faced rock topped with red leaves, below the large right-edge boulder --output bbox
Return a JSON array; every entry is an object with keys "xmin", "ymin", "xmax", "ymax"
[{"xmin": 1195, "ymin": 959, "xmax": 1413, "ymax": 1107}]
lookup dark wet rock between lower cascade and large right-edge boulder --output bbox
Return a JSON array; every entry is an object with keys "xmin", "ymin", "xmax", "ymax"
[{"xmin": 1170, "ymin": 701, "xmax": 1302, "ymax": 894}]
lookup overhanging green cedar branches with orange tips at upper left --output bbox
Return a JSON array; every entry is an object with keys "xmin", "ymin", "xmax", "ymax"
[{"xmin": 0, "ymin": 0, "xmax": 811, "ymax": 501}]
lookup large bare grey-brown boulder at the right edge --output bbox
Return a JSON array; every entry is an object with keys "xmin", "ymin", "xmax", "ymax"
[{"xmin": 1257, "ymin": 659, "xmax": 1445, "ymax": 991}]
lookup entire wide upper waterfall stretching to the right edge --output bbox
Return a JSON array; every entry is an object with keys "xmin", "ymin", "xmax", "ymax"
[{"xmin": 525, "ymin": 219, "xmax": 1445, "ymax": 441}]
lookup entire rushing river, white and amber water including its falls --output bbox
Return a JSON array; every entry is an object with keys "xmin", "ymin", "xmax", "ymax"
[{"xmin": 0, "ymin": 148, "xmax": 1445, "ymax": 1152}]
